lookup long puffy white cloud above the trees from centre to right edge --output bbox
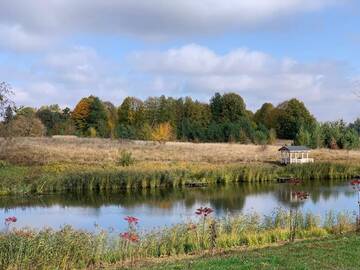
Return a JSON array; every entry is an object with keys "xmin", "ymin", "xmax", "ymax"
[{"xmin": 129, "ymin": 44, "xmax": 360, "ymax": 120}]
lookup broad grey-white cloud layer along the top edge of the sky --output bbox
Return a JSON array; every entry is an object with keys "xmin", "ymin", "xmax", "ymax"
[{"xmin": 0, "ymin": 0, "xmax": 349, "ymax": 50}]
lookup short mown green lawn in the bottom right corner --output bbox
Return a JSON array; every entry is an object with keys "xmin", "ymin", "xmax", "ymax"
[{"xmin": 148, "ymin": 234, "xmax": 360, "ymax": 270}]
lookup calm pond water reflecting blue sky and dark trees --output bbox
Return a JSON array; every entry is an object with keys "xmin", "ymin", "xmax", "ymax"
[{"xmin": 0, "ymin": 180, "xmax": 357, "ymax": 231}]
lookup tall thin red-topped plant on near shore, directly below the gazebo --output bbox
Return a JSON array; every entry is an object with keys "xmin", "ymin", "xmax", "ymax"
[{"xmin": 287, "ymin": 178, "xmax": 310, "ymax": 242}]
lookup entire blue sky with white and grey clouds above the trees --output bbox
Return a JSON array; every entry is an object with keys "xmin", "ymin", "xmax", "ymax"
[{"xmin": 0, "ymin": 0, "xmax": 360, "ymax": 121}]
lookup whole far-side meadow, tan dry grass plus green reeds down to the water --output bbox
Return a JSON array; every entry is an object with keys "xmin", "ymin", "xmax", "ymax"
[{"xmin": 0, "ymin": 137, "xmax": 360, "ymax": 195}]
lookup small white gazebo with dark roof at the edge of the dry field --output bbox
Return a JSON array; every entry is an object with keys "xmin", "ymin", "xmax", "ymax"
[{"xmin": 279, "ymin": 145, "xmax": 314, "ymax": 164}]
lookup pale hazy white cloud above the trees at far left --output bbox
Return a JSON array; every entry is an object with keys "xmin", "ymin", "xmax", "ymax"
[{"xmin": 4, "ymin": 47, "xmax": 127, "ymax": 107}]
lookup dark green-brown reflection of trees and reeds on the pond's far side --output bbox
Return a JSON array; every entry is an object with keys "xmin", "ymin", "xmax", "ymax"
[{"xmin": 0, "ymin": 180, "xmax": 354, "ymax": 212}]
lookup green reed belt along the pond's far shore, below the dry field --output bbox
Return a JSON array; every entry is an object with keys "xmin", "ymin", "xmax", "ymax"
[{"xmin": 0, "ymin": 163, "xmax": 360, "ymax": 195}]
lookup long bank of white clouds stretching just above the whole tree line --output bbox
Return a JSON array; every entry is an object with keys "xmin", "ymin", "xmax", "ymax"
[{"xmin": 0, "ymin": 44, "xmax": 360, "ymax": 121}]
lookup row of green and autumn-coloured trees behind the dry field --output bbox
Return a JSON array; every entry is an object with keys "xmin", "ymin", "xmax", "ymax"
[{"xmin": 0, "ymin": 81, "xmax": 360, "ymax": 149}]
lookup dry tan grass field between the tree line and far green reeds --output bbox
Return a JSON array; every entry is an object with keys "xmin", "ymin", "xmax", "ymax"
[{"xmin": 0, "ymin": 137, "xmax": 360, "ymax": 167}]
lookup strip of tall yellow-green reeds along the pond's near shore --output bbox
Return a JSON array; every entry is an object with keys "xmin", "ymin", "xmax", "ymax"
[{"xmin": 0, "ymin": 210, "xmax": 354, "ymax": 269}]
